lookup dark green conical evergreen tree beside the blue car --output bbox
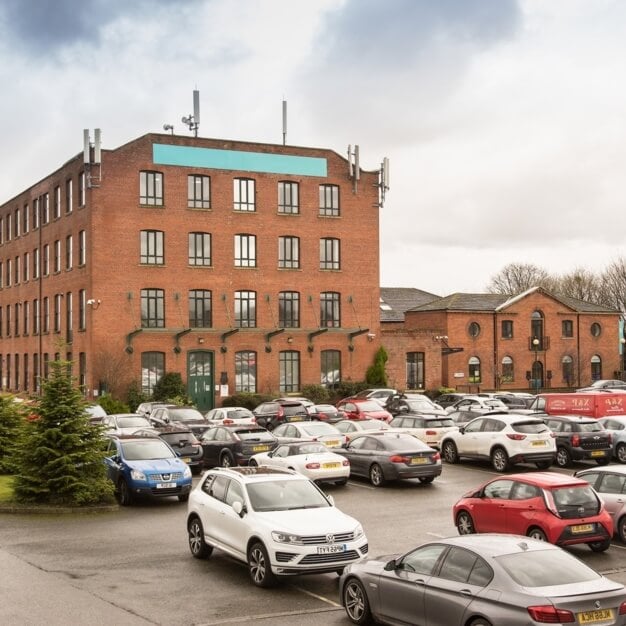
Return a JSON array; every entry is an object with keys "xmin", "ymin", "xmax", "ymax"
[{"xmin": 14, "ymin": 361, "xmax": 113, "ymax": 505}]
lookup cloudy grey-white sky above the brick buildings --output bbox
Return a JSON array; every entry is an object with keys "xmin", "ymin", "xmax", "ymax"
[{"xmin": 0, "ymin": 0, "xmax": 626, "ymax": 295}]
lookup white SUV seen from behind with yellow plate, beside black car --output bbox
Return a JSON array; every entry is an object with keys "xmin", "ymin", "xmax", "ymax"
[{"xmin": 441, "ymin": 413, "xmax": 556, "ymax": 472}]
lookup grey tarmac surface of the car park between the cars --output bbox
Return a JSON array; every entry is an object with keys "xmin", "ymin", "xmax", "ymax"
[{"xmin": 0, "ymin": 463, "xmax": 626, "ymax": 626}]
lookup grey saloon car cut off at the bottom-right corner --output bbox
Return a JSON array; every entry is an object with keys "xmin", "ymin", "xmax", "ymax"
[{"xmin": 339, "ymin": 533, "xmax": 626, "ymax": 626}]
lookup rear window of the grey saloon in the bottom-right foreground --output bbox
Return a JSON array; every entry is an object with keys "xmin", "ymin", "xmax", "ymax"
[{"xmin": 496, "ymin": 550, "xmax": 600, "ymax": 587}]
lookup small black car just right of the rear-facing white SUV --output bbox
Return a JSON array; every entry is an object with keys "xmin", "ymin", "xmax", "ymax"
[{"xmin": 543, "ymin": 415, "xmax": 613, "ymax": 467}]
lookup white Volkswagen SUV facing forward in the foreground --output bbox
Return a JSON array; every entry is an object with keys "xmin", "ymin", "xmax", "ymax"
[{"xmin": 187, "ymin": 466, "xmax": 368, "ymax": 587}]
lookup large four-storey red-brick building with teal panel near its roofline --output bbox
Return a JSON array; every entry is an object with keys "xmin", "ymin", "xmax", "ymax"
[{"xmin": 0, "ymin": 131, "xmax": 382, "ymax": 409}]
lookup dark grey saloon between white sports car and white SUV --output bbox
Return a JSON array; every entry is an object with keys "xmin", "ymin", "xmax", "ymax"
[{"xmin": 341, "ymin": 432, "xmax": 441, "ymax": 487}]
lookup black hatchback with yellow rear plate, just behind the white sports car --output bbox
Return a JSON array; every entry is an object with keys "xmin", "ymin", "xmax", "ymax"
[{"xmin": 200, "ymin": 426, "xmax": 278, "ymax": 469}]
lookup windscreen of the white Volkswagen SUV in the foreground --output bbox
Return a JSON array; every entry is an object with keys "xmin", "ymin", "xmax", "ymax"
[{"xmin": 247, "ymin": 480, "xmax": 331, "ymax": 512}]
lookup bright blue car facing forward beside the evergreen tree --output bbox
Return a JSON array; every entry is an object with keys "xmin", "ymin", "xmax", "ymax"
[{"xmin": 104, "ymin": 435, "xmax": 191, "ymax": 506}]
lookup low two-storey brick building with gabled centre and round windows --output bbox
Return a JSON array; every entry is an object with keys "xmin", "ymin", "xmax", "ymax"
[{"xmin": 381, "ymin": 287, "xmax": 622, "ymax": 391}]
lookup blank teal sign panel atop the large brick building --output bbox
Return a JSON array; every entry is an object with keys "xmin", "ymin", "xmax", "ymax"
[{"xmin": 152, "ymin": 143, "xmax": 328, "ymax": 177}]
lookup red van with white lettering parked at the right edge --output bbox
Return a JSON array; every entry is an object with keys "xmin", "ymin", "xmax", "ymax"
[{"xmin": 525, "ymin": 392, "xmax": 626, "ymax": 418}]
